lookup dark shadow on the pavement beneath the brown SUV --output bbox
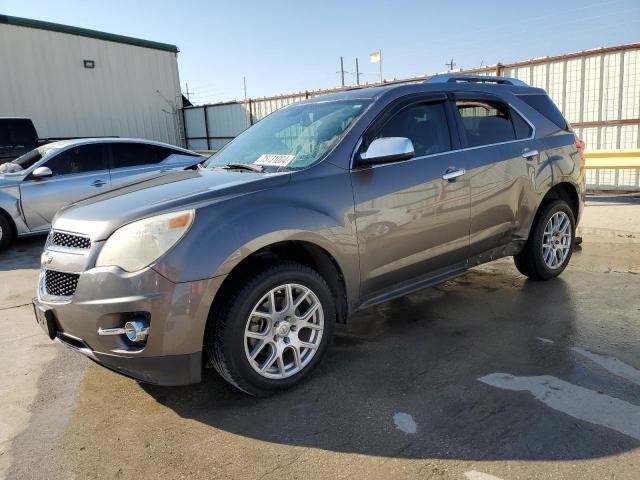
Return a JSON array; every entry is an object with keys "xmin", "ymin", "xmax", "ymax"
[{"xmin": 141, "ymin": 269, "xmax": 640, "ymax": 460}]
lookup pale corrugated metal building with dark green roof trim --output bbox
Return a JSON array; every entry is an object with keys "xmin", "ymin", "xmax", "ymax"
[{"xmin": 0, "ymin": 15, "xmax": 183, "ymax": 145}]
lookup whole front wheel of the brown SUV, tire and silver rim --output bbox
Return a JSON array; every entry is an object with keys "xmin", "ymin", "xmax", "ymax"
[{"xmin": 207, "ymin": 262, "xmax": 336, "ymax": 396}]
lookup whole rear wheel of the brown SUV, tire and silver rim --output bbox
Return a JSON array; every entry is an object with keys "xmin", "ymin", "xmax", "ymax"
[{"xmin": 513, "ymin": 200, "xmax": 575, "ymax": 280}]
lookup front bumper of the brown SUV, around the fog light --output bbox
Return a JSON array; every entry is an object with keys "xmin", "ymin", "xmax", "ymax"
[{"xmin": 34, "ymin": 267, "xmax": 224, "ymax": 385}]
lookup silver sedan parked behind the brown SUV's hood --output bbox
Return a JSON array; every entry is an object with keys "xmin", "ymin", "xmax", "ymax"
[{"xmin": 0, "ymin": 138, "xmax": 206, "ymax": 250}]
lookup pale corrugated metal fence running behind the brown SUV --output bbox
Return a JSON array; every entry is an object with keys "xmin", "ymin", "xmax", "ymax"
[{"xmin": 184, "ymin": 44, "xmax": 640, "ymax": 189}]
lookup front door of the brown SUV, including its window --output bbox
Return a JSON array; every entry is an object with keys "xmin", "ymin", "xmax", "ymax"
[{"xmin": 351, "ymin": 98, "xmax": 470, "ymax": 298}]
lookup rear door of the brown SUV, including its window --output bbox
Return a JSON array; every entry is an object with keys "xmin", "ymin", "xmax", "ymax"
[{"xmin": 455, "ymin": 92, "xmax": 539, "ymax": 256}]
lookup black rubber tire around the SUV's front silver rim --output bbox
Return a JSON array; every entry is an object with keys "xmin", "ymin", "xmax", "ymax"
[{"xmin": 205, "ymin": 262, "xmax": 336, "ymax": 397}]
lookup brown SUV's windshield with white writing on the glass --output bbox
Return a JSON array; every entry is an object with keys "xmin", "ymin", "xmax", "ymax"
[{"xmin": 204, "ymin": 99, "xmax": 371, "ymax": 172}]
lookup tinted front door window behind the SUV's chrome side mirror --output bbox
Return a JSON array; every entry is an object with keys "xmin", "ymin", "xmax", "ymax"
[{"xmin": 376, "ymin": 102, "xmax": 451, "ymax": 157}]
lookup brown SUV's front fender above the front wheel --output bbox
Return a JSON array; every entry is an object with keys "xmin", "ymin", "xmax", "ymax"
[{"xmin": 154, "ymin": 167, "xmax": 360, "ymax": 298}]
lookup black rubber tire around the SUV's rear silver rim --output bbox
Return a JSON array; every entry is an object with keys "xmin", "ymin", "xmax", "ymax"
[{"xmin": 513, "ymin": 200, "xmax": 576, "ymax": 280}]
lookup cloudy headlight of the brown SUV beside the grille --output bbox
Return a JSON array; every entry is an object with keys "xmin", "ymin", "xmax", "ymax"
[{"xmin": 96, "ymin": 210, "xmax": 195, "ymax": 272}]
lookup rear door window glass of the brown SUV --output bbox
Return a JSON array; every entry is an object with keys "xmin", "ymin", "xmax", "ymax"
[{"xmin": 456, "ymin": 100, "xmax": 516, "ymax": 147}]
